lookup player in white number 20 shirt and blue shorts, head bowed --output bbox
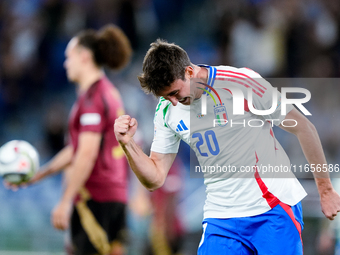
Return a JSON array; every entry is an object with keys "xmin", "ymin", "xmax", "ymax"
[{"xmin": 115, "ymin": 40, "xmax": 340, "ymax": 255}]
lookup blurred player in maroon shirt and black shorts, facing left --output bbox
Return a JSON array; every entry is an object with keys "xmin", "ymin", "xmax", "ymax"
[{"xmin": 6, "ymin": 25, "xmax": 132, "ymax": 255}]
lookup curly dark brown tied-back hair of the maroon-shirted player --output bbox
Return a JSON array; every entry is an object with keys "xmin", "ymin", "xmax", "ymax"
[{"xmin": 76, "ymin": 24, "xmax": 132, "ymax": 69}]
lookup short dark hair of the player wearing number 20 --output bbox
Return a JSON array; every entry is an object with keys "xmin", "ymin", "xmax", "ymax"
[{"xmin": 138, "ymin": 39, "xmax": 191, "ymax": 96}]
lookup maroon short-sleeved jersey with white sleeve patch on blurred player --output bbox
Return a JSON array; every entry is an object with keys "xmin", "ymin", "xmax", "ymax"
[{"xmin": 69, "ymin": 76, "xmax": 127, "ymax": 203}]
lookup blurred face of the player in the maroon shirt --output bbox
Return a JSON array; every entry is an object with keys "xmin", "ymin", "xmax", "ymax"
[{"xmin": 64, "ymin": 38, "xmax": 81, "ymax": 82}]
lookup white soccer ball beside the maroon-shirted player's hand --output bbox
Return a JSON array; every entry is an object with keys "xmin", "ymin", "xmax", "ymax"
[{"xmin": 0, "ymin": 140, "xmax": 39, "ymax": 184}]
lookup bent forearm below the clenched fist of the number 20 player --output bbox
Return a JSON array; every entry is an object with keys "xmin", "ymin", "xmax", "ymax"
[{"xmin": 121, "ymin": 139, "xmax": 165, "ymax": 191}]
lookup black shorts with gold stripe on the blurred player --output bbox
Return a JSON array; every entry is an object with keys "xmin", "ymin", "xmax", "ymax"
[{"xmin": 71, "ymin": 199, "xmax": 126, "ymax": 255}]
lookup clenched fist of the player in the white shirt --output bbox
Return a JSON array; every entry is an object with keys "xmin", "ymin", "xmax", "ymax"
[{"xmin": 114, "ymin": 115, "xmax": 138, "ymax": 145}]
